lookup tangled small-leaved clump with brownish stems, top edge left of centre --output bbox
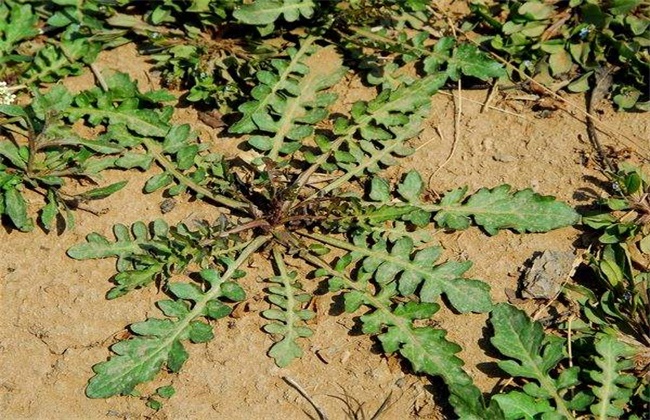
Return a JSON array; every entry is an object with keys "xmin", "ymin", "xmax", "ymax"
[{"xmin": 108, "ymin": 1, "xmax": 270, "ymax": 110}]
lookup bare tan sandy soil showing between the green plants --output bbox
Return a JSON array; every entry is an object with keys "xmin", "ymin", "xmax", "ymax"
[{"xmin": 0, "ymin": 39, "xmax": 650, "ymax": 419}]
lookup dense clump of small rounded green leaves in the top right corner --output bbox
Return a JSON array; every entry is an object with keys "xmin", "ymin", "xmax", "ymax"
[{"xmin": 471, "ymin": 0, "xmax": 650, "ymax": 110}]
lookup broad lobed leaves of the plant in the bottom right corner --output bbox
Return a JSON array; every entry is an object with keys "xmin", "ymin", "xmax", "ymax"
[{"xmin": 476, "ymin": 304, "xmax": 645, "ymax": 419}]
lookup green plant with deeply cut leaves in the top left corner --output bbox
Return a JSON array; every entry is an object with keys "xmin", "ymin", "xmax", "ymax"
[{"xmin": 0, "ymin": 0, "xmax": 133, "ymax": 87}]
